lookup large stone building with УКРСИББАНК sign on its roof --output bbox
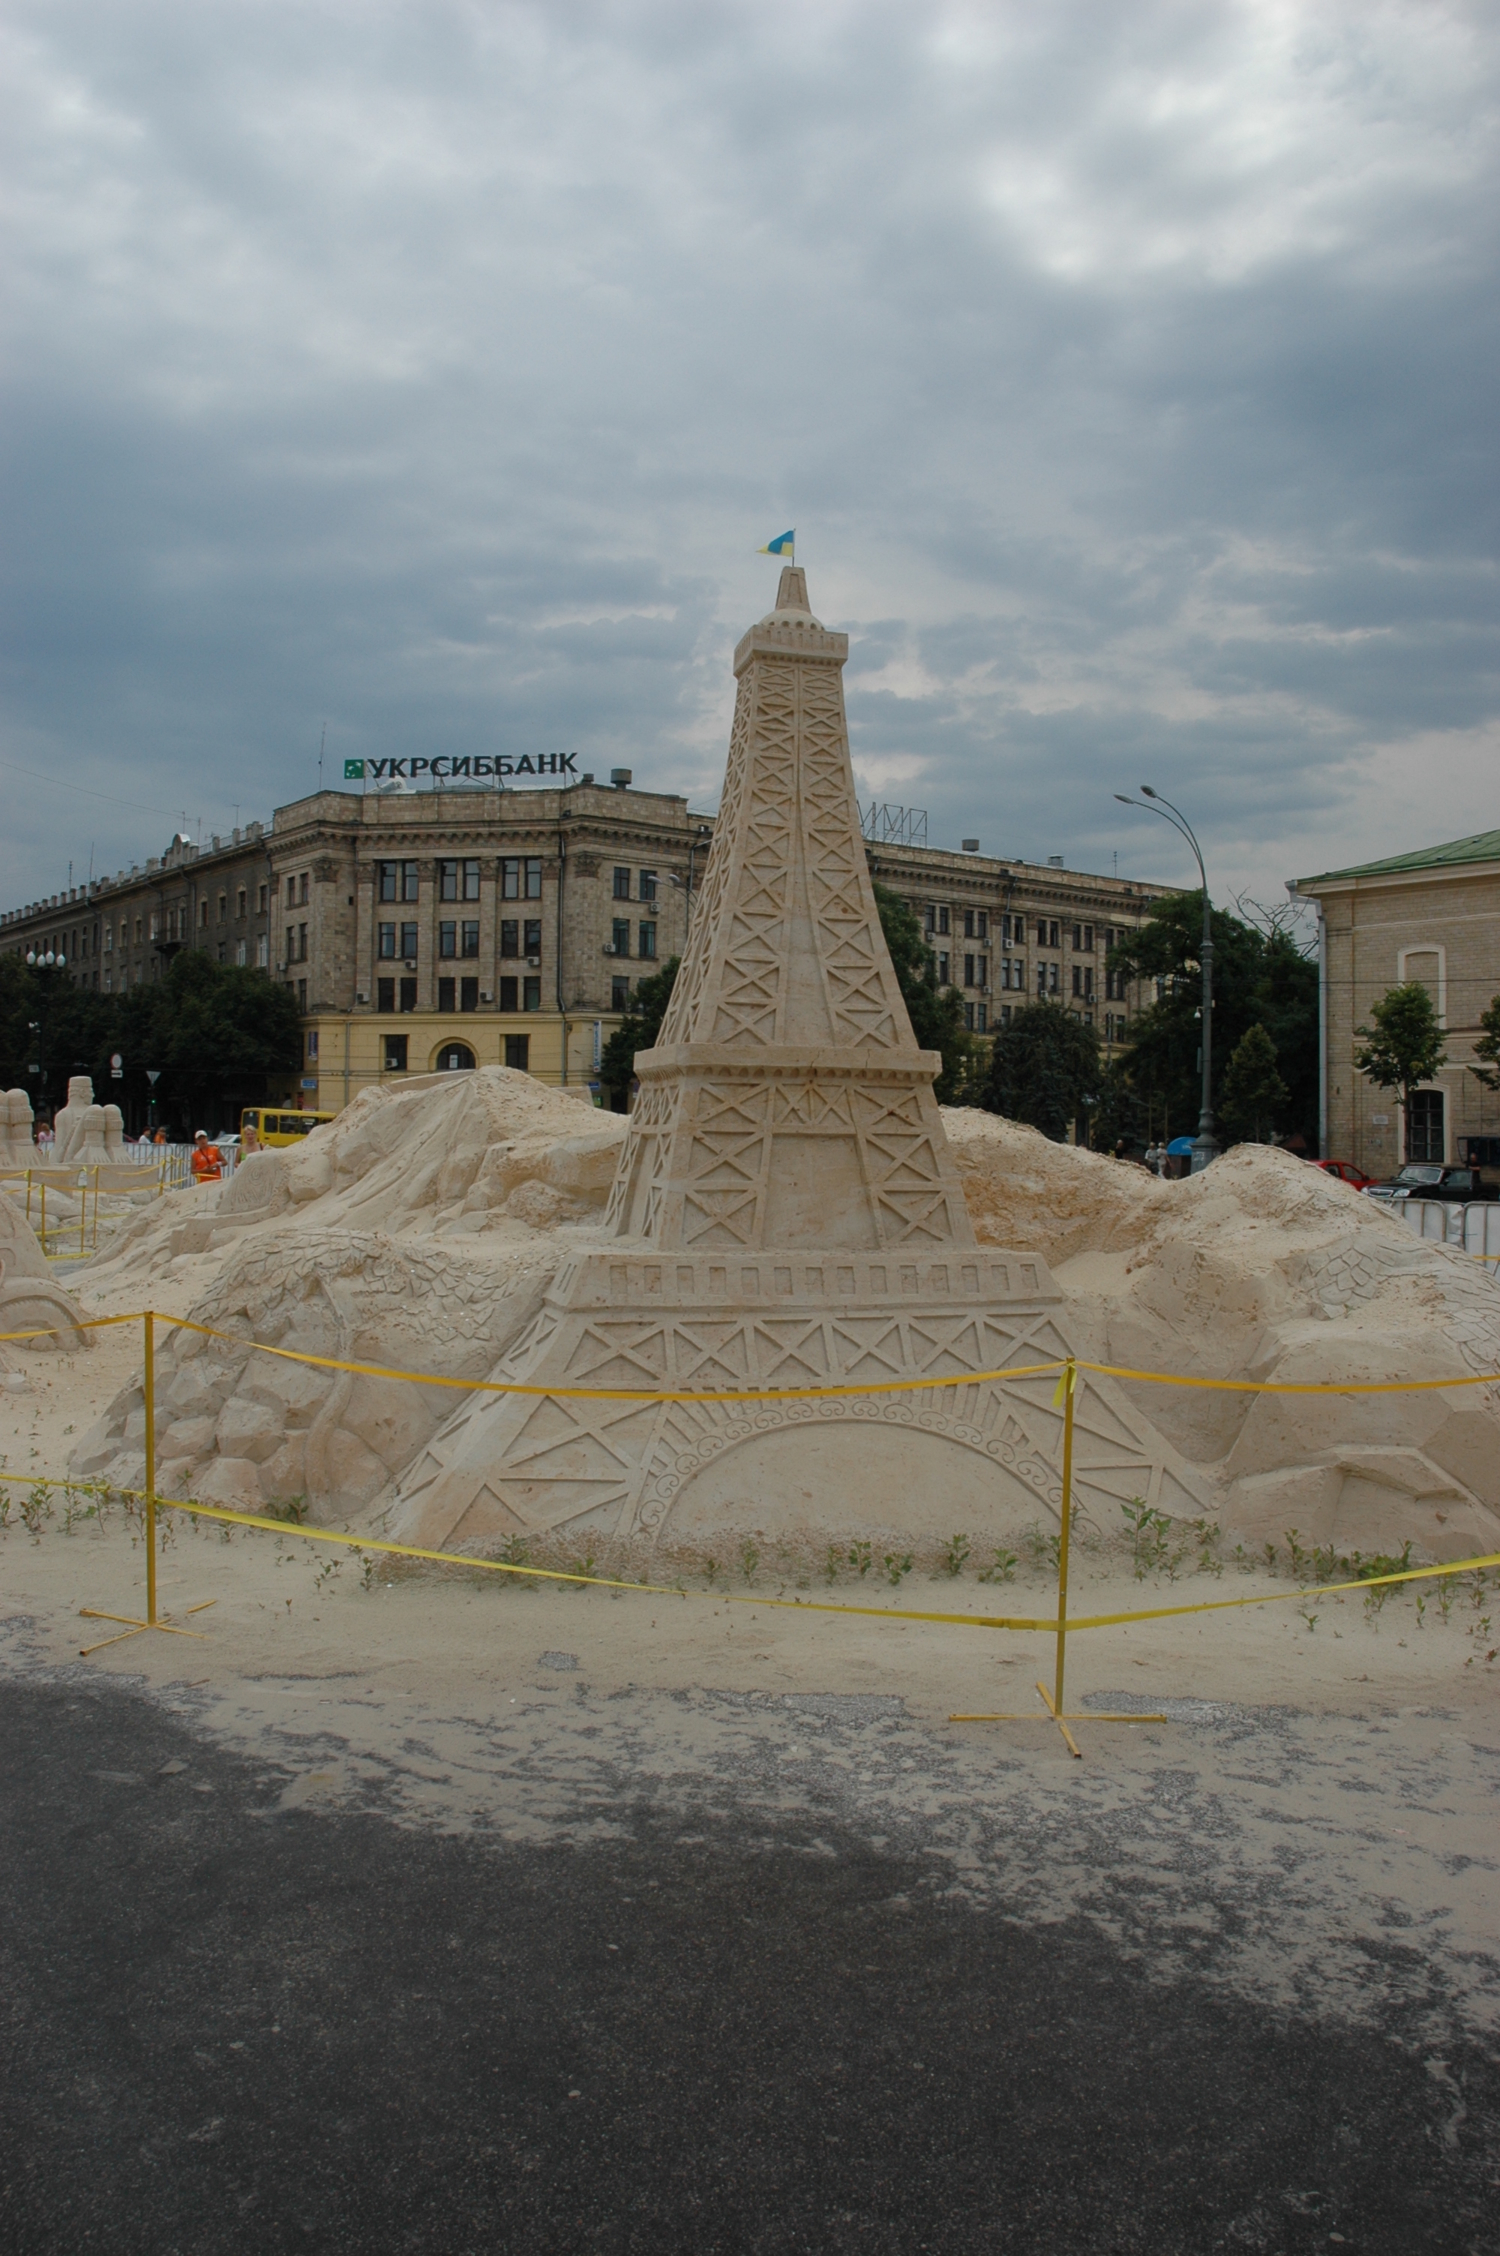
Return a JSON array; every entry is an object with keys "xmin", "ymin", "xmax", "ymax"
[{"xmin": 0, "ymin": 776, "xmax": 1164, "ymax": 1112}]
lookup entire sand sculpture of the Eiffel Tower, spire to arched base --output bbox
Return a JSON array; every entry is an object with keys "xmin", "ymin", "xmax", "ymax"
[{"xmin": 386, "ymin": 566, "xmax": 1202, "ymax": 1548}]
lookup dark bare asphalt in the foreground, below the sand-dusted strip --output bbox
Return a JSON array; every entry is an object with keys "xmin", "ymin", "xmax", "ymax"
[{"xmin": 0, "ymin": 1683, "xmax": 1500, "ymax": 2256}]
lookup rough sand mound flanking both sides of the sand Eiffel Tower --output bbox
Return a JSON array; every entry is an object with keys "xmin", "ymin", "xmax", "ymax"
[{"xmin": 74, "ymin": 1069, "xmax": 1500, "ymax": 1557}]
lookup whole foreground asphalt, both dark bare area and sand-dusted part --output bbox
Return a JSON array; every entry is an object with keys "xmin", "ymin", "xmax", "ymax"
[{"xmin": 0, "ymin": 1656, "xmax": 1500, "ymax": 2256}]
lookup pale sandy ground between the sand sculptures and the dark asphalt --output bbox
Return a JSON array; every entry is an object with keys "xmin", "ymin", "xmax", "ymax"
[{"xmin": 0, "ymin": 1261, "xmax": 1500, "ymax": 2073}]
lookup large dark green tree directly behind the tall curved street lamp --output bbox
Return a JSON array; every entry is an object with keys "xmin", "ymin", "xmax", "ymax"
[{"xmin": 1108, "ymin": 893, "xmax": 1317, "ymax": 1144}]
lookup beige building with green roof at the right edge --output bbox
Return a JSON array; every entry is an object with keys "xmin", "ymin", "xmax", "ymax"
[{"xmin": 1290, "ymin": 830, "xmax": 1500, "ymax": 1175}]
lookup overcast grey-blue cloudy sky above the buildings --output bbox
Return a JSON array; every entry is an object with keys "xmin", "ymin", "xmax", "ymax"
[{"xmin": 0, "ymin": 0, "xmax": 1500, "ymax": 907}]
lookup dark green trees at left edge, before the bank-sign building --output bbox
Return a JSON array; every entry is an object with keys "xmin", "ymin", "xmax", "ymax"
[{"xmin": 0, "ymin": 948, "xmax": 302, "ymax": 1130}]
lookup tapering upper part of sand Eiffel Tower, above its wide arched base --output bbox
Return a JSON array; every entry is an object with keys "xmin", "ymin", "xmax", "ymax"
[{"xmin": 609, "ymin": 564, "xmax": 974, "ymax": 1250}]
